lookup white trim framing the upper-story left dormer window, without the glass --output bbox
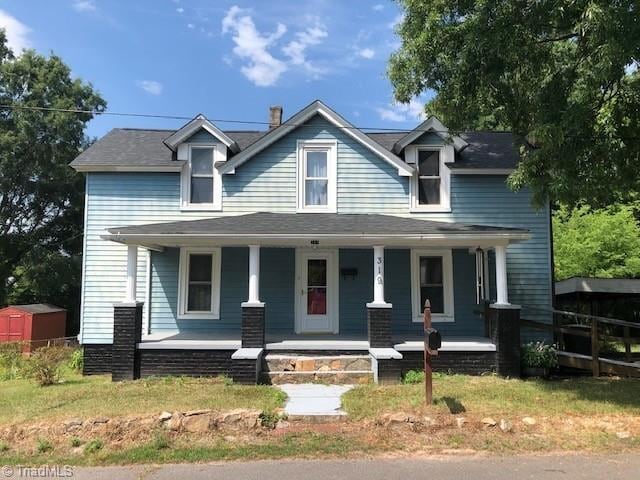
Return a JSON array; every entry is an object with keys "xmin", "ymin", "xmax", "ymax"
[{"xmin": 178, "ymin": 143, "xmax": 227, "ymax": 212}]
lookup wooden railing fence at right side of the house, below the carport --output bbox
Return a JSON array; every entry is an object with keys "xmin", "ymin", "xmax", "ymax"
[{"xmin": 520, "ymin": 309, "xmax": 640, "ymax": 377}]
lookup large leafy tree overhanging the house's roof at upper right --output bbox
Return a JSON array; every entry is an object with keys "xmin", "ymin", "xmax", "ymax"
[{"xmin": 388, "ymin": 0, "xmax": 640, "ymax": 206}]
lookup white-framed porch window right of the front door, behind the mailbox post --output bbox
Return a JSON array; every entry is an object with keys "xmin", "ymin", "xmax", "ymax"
[{"xmin": 411, "ymin": 250, "xmax": 454, "ymax": 322}]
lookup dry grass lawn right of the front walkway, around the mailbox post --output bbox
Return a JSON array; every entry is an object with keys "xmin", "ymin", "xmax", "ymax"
[{"xmin": 343, "ymin": 374, "xmax": 640, "ymax": 419}]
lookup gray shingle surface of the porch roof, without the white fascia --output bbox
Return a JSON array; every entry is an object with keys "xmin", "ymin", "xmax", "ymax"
[{"xmin": 108, "ymin": 212, "xmax": 528, "ymax": 236}]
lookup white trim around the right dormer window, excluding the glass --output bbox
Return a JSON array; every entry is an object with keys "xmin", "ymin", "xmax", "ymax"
[{"xmin": 405, "ymin": 145, "xmax": 455, "ymax": 213}]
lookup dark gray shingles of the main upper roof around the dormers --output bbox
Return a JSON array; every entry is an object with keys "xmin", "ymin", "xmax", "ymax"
[{"xmin": 71, "ymin": 128, "xmax": 519, "ymax": 169}]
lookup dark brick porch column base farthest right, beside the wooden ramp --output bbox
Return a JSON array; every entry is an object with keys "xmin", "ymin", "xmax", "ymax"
[{"xmin": 489, "ymin": 304, "xmax": 520, "ymax": 377}]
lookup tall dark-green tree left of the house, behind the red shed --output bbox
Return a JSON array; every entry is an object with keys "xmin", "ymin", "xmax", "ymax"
[{"xmin": 0, "ymin": 30, "xmax": 106, "ymax": 330}]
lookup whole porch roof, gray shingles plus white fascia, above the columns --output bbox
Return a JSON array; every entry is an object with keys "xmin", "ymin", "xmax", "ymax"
[{"xmin": 103, "ymin": 212, "xmax": 530, "ymax": 251}]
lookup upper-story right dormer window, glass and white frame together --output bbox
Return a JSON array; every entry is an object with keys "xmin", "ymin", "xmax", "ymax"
[{"xmin": 405, "ymin": 145, "xmax": 454, "ymax": 212}]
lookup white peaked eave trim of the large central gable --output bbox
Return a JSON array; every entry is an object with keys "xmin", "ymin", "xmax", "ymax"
[{"xmin": 219, "ymin": 100, "xmax": 413, "ymax": 177}]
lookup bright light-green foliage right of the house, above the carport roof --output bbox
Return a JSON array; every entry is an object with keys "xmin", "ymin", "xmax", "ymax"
[{"xmin": 553, "ymin": 206, "xmax": 640, "ymax": 280}]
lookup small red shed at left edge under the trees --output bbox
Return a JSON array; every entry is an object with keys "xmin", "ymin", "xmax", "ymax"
[{"xmin": 0, "ymin": 303, "xmax": 67, "ymax": 352}]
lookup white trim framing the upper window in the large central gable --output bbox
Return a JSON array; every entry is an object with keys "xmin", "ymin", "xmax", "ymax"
[{"xmin": 296, "ymin": 140, "xmax": 338, "ymax": 213}]
